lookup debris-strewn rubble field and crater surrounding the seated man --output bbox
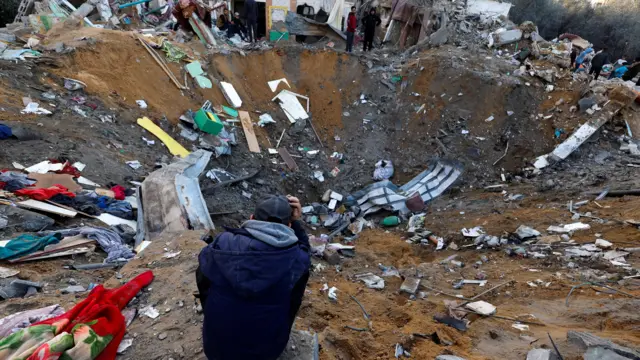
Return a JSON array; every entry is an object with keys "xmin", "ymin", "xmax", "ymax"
[{"xmin": 0, "ymin": 0, "xmax": 640, "ymax": 360}]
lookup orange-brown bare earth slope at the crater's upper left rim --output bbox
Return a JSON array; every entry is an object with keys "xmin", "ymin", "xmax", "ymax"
[{"xmin": 48, "ymin": 29, "xmax": 223, "ymax": 119}]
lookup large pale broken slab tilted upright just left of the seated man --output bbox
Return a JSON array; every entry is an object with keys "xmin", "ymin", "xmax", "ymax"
[{"xmin": 141, "ymin": 150, "xmax": 215, "ymax": 239}]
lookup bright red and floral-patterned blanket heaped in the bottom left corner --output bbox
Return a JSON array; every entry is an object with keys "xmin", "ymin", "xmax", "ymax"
[{"xmin": 0, "ymin": 271, "xmax": 153, "ymax": 360}]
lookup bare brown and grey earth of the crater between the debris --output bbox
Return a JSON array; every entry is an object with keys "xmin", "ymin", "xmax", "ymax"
[{"xmin": 0, "ymin": 29, "xmax": 640, "ymax": 360}]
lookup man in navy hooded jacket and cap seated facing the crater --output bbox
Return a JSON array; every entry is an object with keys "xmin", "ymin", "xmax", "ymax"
[{"xmin": 196, "ymin": 196, "xmax": 310, "ymax": 360}]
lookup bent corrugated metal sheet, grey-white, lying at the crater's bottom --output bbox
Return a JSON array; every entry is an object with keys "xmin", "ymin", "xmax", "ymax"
[{"xmin": 352, "ymin": 160, "xmax": 462, "ymax": 214}]
